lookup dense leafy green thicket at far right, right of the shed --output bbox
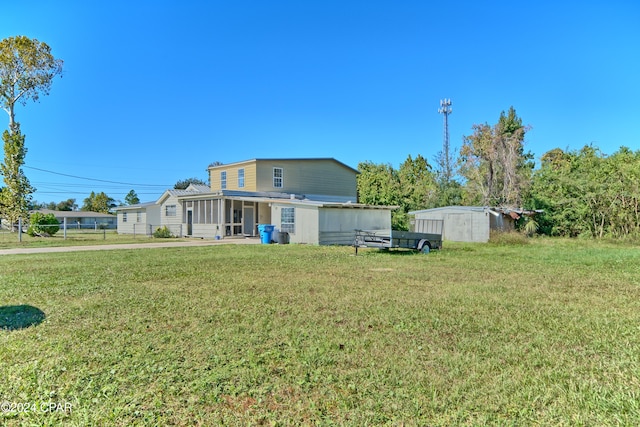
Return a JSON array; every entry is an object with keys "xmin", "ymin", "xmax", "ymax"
[{"xmin": 527, "ymin": 145, "xmax": 640, "ymax": 238}]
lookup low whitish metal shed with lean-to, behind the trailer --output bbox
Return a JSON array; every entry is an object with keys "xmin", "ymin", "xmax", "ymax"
[{"xmin": 409, "ymin": 206, "xmax": 538, "ymax": 243}]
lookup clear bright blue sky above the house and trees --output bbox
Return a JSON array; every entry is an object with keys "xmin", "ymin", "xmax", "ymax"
[{"xmin": 0, "ymin": 0, "xmax": 640, "ymax": 205}]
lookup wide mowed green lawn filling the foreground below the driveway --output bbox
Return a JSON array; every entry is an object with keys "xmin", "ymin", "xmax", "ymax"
[{"xmin": 0, "ymin": 239, "xmax": 640, "ymax": 426}]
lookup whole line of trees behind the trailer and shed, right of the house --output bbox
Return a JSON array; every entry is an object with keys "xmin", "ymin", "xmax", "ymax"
[{"xmin": 358, "ymin": 107, "xmax": 640, "ymax": 238}]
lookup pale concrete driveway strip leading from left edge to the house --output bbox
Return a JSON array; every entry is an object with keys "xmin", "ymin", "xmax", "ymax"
[{"xmin": 0, "ymin": 238, "xmax": 260, "ymax": 255}]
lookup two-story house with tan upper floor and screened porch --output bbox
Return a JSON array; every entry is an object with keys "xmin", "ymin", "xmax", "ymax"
[{"xmin": 118, "ymin": 158, "xmax": 393, "ymax": 244}]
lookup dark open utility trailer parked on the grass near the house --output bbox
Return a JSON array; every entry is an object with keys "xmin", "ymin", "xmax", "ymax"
[{"xmin": 353, "ymin": 220, "xmax": 443, "ymax": 255}]
